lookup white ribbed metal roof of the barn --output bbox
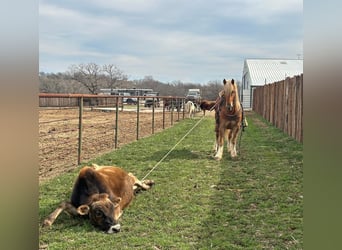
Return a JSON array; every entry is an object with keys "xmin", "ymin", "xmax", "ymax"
[{"xmin": 243, "ymin": 59, "xmax": 303, "ymax": 86}]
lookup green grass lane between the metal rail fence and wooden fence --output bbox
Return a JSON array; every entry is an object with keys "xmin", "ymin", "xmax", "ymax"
[{"xmin": 39, "ymin": 113, "xmax": 303, "ymax": 249}]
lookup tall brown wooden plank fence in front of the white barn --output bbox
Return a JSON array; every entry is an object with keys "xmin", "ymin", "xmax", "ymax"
[{"xmin": 253, "ymin": 74, "xmax": 303, "ymax": 142}]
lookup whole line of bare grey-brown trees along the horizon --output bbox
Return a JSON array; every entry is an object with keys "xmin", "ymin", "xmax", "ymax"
[{"xmin": 39, "ymin": 63, "xmax": 240, "ymax": 100}]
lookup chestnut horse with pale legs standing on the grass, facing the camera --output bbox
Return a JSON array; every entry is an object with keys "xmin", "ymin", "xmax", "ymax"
[{"xmin": 214, "ymin": 79, "xmax": 243, "ymax": 160}]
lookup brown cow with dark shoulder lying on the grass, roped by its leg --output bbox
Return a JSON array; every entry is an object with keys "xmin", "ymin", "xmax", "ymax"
[{"xmin": 43, "ymin": 164, "xmax": 154, "ymax": 233}]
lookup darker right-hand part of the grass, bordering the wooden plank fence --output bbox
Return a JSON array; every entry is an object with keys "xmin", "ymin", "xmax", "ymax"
[{"xmin": 195, "ymin": 113, "xmax": 303, "ymax": 249}]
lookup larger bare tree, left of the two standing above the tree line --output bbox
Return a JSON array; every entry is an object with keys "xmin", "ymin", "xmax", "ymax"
[{"xmin": 70, "ymin": 63, "xmax": 103, "ymax": 94}]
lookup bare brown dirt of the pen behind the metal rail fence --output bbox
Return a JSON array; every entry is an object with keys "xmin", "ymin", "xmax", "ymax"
[{"xmin": 39, "ymin": 108, "xmax": 202, "ymax": 182}]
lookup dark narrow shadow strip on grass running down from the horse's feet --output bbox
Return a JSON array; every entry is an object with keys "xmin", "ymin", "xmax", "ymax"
[{"xmin": 194, "ymin": 159, "xmax": 255, "ymax": 249}]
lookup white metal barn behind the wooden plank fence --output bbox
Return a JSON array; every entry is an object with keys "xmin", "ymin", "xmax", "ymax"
[{"xmin": 240, "ymin": 59, "xmax": 303, "ymax": 109}]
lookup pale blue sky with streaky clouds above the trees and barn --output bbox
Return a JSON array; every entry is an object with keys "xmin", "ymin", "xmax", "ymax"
[{"xmin": 39, "ymin": 0, "xmax": 303, "ymax": 84}]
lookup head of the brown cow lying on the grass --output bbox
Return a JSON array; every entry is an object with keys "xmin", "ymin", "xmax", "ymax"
[{"xmin": 77, "ymin": 193, "xmax": 122, "ymax": 233}]
